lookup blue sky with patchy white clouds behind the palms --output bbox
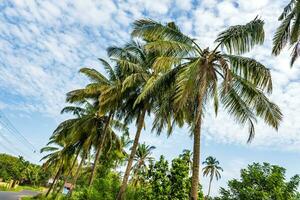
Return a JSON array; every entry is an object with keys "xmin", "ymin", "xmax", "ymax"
[{"xmin": 0, "ymin": 0, "xmax": 300, "ymax": 195}]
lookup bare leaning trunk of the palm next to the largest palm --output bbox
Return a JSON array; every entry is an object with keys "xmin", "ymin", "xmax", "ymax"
[{"xmin": 117, "ymin": 107, "xmax": 146, "ymax": 200}]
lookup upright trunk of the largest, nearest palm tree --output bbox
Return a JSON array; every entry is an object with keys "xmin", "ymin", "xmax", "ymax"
[{"xmin": 191, "ymin": 81, "xmax": 206, "ymax": 200}]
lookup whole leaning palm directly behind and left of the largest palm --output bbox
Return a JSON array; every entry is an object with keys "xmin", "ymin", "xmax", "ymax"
[{"xmin": 112, "ymin": 41, "xmax": 162, "ymax": 200}]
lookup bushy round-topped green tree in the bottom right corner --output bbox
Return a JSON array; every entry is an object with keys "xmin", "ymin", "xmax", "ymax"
[{"xmin": 216, "ymin": 163, "xmax": 300, "ymax": 200}]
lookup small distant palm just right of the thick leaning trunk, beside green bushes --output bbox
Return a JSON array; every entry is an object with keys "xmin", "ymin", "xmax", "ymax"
[{"xmin": 132, "ymin": 143, "xmax": 155, "ymax": 185}]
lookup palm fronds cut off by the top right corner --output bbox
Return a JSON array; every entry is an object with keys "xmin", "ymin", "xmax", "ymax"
[{"xmin": 272, "ymin": 0, "xmax": 300, "ymax": 67}]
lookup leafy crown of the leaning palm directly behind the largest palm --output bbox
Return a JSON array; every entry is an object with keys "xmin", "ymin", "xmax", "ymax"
[{"xmin": 107, "ymin": 41, "xmax": 153, "ymax": 123}]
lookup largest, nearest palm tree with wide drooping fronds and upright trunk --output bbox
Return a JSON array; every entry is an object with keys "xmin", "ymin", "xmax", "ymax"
[{"xmin": 132, "ymin": 18, "xmax": 282, "ymax": 200}]
